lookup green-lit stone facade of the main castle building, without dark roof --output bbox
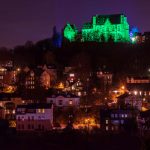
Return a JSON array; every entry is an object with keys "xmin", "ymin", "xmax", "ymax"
[{"xmin": 82, "ymin": 15, "xmax": 130, "ymax": 42}]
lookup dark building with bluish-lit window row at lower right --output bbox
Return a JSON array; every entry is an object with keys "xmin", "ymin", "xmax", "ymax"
[{"xmin": 100, "ymin": 108, "xmax": 138, "ymax": 132}]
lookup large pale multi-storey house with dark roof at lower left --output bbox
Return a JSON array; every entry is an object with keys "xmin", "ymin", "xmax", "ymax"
[{"xmin": 16, "ymin": 103, "xmax": 53, "ymax": 131}]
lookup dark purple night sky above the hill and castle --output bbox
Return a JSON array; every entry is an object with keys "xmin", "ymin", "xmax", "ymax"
[{"xmin": 0, "ymin": 0, "xmax": 150, "ymax": 48}]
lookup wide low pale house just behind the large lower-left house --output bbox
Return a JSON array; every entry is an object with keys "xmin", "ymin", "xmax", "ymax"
[{"xmin": 47, "ymin": 94, "xmax": 80, "ymax": 107}]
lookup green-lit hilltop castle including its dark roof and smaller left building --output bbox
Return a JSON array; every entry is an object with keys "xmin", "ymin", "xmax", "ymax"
[{"xmin": 64, "ymin": 14, "xmax": 130, "ymax": 42}]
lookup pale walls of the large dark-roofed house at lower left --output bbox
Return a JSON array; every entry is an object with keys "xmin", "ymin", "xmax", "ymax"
[{"xmin": 16, "ymin": 109, "xmax": 53, "ymax": 131}]
